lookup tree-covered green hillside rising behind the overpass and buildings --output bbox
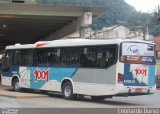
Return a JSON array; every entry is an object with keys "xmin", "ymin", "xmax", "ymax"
[{"xmin": 35, "ymin": 0, "xmax": 160, "ymax": 36}]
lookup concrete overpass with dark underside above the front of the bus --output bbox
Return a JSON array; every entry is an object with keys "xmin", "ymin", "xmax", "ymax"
[{"xmin": 0, "ymin": 3, "xmax": 105, "ymax": 47}]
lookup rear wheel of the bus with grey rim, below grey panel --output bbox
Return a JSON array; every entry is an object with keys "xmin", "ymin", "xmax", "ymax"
[{"xmin": 62, "ymin": 81, "xmax": 75, "ymax": 100}]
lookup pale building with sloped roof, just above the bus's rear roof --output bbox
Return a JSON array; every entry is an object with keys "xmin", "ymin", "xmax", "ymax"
[{"xmin": 92, "ymin": 25, "xmax": 152, "ymax": 41}]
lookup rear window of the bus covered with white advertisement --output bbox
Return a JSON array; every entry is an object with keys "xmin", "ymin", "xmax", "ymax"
[{"xmin": 120, "ymin": 42, "xmax": 155, "ymax": 64}]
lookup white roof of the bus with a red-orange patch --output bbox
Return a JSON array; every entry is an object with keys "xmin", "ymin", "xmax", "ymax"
[{"xmin": 6, "ymin": 39, "xmax": 154, "ymax": 49}]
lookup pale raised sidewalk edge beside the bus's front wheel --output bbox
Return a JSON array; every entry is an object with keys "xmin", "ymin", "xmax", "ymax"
[{"xmin": 0, "ymin": 83, "xmax": 48, "ymax": 99}]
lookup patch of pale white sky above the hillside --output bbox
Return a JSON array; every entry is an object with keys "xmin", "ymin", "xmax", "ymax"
[{"xmin": 125, "ymin": 0, "xmax": 160, "ymax": 13}]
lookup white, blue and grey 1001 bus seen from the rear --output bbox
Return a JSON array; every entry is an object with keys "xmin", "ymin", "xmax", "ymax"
[{"xmin": 1, "ymin": 39, "xmax": 156, "ymax": 100}]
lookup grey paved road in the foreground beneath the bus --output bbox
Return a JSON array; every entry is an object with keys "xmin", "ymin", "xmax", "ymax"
[{"xmin": 0, "ymin": 90, "xmax": 160, "ymax": 114}]
